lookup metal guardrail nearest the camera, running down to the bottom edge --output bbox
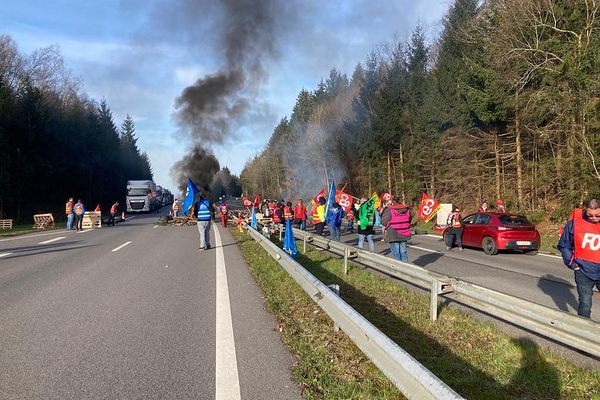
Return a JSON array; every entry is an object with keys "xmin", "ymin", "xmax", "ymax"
[{"xmin": 248, "ymin": 226, "xmax": 463, "ymax": 400}]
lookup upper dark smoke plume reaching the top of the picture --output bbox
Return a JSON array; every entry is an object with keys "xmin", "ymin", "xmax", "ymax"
[{"xmin": 175, "ymin": 0, "xmax": 287, "ymax": 145}]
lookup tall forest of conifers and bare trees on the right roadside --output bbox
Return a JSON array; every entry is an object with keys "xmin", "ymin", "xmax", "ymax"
[{"xmin": 240, "ymin": 0, "xmax": 600, "ymax": 220}]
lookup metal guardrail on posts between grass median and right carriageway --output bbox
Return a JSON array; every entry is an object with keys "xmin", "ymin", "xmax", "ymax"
[{"xmin": 294, "ymin": 229, "xmax": 600, "ymax": 357}]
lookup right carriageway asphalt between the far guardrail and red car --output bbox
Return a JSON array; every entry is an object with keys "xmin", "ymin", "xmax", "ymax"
[{"xmin": 330, "ymin": 226, "xmax": 600, "ymax": 321}]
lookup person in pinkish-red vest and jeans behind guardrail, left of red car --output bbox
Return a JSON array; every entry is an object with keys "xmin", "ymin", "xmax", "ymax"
[{"xmin": 381, "ymin": 197, "xmax": 411, "ymax": 262}]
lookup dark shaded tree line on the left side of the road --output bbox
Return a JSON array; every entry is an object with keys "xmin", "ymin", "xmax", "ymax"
[{"xmin": 0, "ymin": 35, "xmax": 152, "ymax": 222}]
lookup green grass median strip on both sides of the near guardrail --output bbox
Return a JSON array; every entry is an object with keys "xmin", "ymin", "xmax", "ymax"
[{"xmin": 234, "ymin": 228, "xmax": 600, "ymax": 399}]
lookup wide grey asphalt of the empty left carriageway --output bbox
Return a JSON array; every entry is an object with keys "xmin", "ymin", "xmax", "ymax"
[{"xmin": 0, "ymin": 211, "xmax": 301, "ymax": 400}]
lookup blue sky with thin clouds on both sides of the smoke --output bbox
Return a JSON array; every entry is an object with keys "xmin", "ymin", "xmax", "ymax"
[{"xmin": 0, "ymin": 0, "xmax": 451, "ymax": 194}]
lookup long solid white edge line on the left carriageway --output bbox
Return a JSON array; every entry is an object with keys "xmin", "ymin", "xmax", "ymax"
[{"xmin": 214, "ymin": 226, "xmax": 241, "ymax": 400}]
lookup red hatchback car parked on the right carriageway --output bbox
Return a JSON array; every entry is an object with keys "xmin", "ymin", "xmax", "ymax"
[{"xmin": 444, "ymin": 212, "xmax": 541, "ymax": 255}]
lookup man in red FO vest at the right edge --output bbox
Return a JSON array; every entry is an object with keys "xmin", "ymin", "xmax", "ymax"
[{"xmin": 556, "ymin": 198, "xmax": 600, "ymax": 318}]
